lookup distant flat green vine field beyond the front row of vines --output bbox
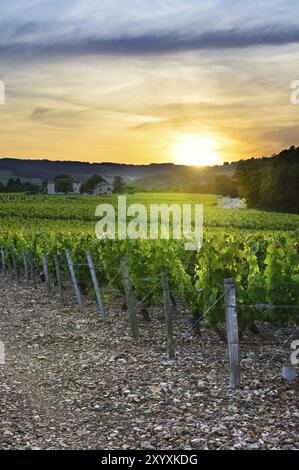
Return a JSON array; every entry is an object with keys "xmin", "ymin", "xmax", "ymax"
[{"xmin": 0, "ymin": 193, "xmax": 299, "ymax": 234}]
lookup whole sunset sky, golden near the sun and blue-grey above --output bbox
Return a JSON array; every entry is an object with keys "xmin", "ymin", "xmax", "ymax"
[{"xmin": 0, "ymin": 0, "xmax": 299, "ymax": 165}]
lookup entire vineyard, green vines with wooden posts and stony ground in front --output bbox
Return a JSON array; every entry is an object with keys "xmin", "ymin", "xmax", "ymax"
[{"xmin": 0, "ymin": 194, "xmax": 299, "ymax": 452}]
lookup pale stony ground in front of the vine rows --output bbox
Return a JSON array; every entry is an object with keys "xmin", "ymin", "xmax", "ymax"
[{"xmin": 0, "ymin": 276, "xmax": 298, "ymax": 449}]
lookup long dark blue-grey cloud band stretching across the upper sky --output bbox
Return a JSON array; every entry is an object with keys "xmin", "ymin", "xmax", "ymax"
[{"xmin": 0, "ymin": 26, "xmax": 299, "ymax": 58}]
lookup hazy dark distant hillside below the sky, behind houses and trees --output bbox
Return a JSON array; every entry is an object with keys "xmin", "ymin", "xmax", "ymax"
[{"xmin": 0, "ymin": 158, "xmax": 236, "ymax": 189}]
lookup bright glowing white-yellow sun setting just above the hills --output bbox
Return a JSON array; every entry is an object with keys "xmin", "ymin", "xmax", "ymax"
[{"xmin": 172, "ymin": 134, "xmax": 220, "ymax": 166}]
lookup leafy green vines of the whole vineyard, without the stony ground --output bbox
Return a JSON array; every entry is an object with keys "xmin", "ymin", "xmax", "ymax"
[{"xmin": 0, "ymin": 193, "xmax": 299, "ymax": 329}]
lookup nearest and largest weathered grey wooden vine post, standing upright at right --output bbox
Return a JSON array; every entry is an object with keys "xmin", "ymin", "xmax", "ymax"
[{"xmin": 224, "ymin": 279, "xmax": 240, "ymax": 388}]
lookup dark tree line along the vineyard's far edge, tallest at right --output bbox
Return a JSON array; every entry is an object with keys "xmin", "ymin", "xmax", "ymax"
[{"xmin": 0, "ymin": 146, "xmax": 299, "ymax": 213}]
